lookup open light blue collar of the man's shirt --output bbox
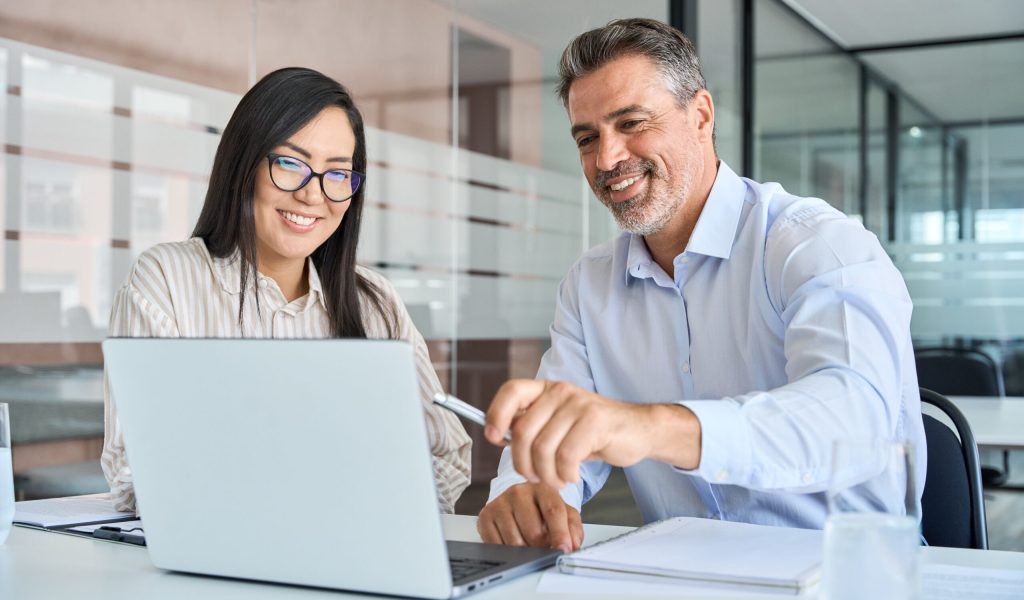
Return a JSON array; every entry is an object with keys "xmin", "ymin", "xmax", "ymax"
[{"xmin": 626, "ymin": 161, "xmax": 746, "ymax": 285}]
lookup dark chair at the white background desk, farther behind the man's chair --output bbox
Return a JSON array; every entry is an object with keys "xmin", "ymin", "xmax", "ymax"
[{"xmin": 914, "ymin": 346, "xmax": 1010, "ymax": 486}]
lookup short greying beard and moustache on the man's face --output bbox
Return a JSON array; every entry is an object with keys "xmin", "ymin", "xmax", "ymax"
[{"xmin": 594, "ymin": 160, "xmax": 694, "ymax": 235}]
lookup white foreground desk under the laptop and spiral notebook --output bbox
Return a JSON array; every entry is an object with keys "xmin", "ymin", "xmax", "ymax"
[{"xmin": 0, "ymin": 516, "xmax": 1024, "ymax": 600}]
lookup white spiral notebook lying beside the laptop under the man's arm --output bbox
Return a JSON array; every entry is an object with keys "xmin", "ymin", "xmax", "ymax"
[{"xmin": 558, "ymin": 517, "xmax": 822, "ymax": 594}]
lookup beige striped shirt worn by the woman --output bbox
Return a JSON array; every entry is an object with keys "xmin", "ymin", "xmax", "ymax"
[{"xmin": 101, "ymin": 239, "xmax": 472, "ymax": 513}]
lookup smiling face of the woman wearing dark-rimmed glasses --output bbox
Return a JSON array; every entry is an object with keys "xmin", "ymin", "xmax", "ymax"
[{"xmin": 253, "ymin": 106, "xmax": 355, "ymax": 274}]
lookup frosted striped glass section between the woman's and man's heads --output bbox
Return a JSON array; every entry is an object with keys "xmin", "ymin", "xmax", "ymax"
[{"xmin": 359, "ymin": 130, "xmax": 597, "ymax": 339}]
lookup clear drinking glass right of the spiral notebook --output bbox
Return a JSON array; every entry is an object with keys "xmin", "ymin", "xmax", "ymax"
[{"xmin": 821, "ymin": 439, "xmax": 921, "ymax": 600}]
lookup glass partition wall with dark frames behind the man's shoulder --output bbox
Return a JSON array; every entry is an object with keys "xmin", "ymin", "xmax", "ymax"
[{"xmin": 750, "ymin": 0, "xmax": 1024, "ymax": 360}]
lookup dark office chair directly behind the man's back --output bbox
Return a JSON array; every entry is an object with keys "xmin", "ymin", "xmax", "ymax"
[{"xmin": 921, "ymin": 388, "xmax": 988, "ymax": 550}]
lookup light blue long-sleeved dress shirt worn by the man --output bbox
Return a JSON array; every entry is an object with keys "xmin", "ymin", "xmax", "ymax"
[{"xmin": 490, "ymin": 163, "xmax": 926, "ymax": 528}]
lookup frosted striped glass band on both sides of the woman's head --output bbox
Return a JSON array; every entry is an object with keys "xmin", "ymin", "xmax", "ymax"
[{"xmin": 0, "ymin": 33, "xmax": 596, "ymax": 342}]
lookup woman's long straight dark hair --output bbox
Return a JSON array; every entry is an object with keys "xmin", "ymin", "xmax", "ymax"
[{"xmin": 193, "ymin": 68, "xmax": 397, "ymax": 338}]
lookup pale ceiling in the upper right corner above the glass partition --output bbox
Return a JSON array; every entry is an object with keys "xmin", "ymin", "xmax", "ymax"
[{"xmin": 782, "ymin": 0, "xmax": 1024, "ymax": 123}]
